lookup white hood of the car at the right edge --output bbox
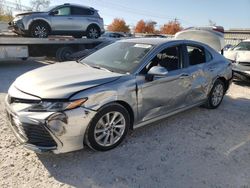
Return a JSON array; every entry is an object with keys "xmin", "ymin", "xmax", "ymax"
[{"xmin": 224, "ymin": 50, "xmax": 250, "ymax": 62}]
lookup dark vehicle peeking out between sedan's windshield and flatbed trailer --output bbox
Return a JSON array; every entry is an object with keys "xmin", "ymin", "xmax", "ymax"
[{"xmin": 68, "ymin": 39, "xmax": 117, "ymax": 61}]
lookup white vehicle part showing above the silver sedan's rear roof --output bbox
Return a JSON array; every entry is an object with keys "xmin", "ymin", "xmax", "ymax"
[{"xmin": 175, "ymin": 26, "xmax": 225, "ymax": 53}]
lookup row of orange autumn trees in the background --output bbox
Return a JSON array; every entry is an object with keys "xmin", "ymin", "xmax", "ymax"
[{"xmin": 107, "ymin": 18, "xmax": 183, "ymax": 35}]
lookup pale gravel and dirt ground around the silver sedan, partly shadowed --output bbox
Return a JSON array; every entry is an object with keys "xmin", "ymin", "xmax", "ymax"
[{"xmin": 0, "ymin": 61, "xmax": 250, "ymax": 188}]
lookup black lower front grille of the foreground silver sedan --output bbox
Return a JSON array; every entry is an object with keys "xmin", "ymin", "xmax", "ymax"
[{"xmin": 9, "ymin": 112, "xmax": 57, "ymax": 147}]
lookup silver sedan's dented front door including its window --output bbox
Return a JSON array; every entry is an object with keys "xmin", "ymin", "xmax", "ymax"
[{"xmin": 137, "ymin": 46, "xmax": 191, "ymax": 121}]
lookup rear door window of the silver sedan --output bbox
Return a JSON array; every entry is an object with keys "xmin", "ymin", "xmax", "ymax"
[{"xmin": 187, "ymin": 46, "xmax": 206, "ymax": 66}]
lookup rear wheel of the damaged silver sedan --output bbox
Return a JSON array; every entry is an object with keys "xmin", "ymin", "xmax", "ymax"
[{"xmin": 204, "ymin": 79, "xmax": 226, "ymax": 109}]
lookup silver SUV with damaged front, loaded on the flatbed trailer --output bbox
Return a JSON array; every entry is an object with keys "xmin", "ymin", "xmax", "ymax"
[{"xmin": 9, "ymin": 3, "xmax": 104, "ymax": 39}]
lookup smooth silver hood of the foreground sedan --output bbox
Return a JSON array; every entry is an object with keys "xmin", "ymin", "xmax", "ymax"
[{"xmin": 13, "ymin": 62, "xmax": 122, "ymax": 99}]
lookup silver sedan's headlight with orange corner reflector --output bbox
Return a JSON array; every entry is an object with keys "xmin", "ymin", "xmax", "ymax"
[{"xmin": 28, "ymin": 98, "xmax": 87, "ymax": 112}]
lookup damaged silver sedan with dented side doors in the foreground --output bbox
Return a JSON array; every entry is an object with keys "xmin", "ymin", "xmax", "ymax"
[{"xmin": 6, "ymin": 38, "xmax": 232, "ymax": 153}]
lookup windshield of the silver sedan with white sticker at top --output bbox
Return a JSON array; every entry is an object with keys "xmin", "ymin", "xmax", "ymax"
[{"xmin": 80, "ymin": 42, "xmax": 153, "ymax": 74}]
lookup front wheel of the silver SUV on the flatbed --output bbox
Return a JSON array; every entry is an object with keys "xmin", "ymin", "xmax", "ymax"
[{"xmin": 30, "ymin": 22, "xmax": 49, "ymax": 38}]
